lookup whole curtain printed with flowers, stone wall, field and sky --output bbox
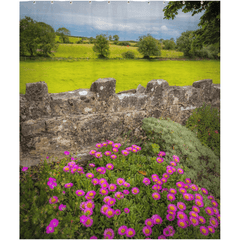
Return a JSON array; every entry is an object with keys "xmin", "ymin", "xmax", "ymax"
[{"xmin": 19, "ymin": 0, "xmax": 221, "ymax": 239}]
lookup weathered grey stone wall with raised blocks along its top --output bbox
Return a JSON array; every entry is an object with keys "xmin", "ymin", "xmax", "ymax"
[{"xmin": 20, "ymin": 78, "xmax": 220, "ymax": 167}]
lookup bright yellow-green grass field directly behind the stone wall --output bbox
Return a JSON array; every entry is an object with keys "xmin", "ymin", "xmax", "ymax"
[{"xmin": 20, "ymin": 59, "xmax": 220, "ymax": 94}]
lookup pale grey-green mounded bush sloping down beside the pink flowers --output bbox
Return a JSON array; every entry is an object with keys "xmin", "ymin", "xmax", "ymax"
[{"xmin": 141, "ymin": 117, "xmax": 220, "ymax": 199}]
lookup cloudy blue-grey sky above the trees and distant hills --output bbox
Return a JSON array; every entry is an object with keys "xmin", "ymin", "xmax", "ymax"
[{"xmin": 19, "ymin": 1, "xmax": 204, "ymax": 41}]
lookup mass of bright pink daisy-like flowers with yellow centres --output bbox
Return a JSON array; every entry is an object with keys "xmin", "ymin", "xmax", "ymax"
[{"xmin": 22, "ymin": 140, "xmax": 220, "ymax": 239}]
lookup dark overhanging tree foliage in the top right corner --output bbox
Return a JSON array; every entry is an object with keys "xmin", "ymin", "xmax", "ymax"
[{"xmin": 163, "ymin": 1, "xmax": 220, "ymax": 48}]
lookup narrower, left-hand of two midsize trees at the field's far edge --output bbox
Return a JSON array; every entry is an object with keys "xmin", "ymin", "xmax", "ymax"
[{"xmin": 93, "ymin": 34, "xmax": 110, "ymax": 58}]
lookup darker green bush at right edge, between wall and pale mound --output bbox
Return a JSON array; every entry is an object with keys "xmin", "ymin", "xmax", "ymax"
[{"xmin": 185, "ymin": 103, "xmax": 220, "ymax": 158}]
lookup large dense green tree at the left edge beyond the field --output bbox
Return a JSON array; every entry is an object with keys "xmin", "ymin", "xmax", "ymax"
[{"xmin": 20, "ymin": 17, "xmax": 57, "ymax": 57}]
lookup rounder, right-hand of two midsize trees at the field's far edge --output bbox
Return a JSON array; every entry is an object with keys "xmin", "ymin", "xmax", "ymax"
[{"xmin": 137, "ymin": 34, "xmax": 161, "ymax": 58}]
